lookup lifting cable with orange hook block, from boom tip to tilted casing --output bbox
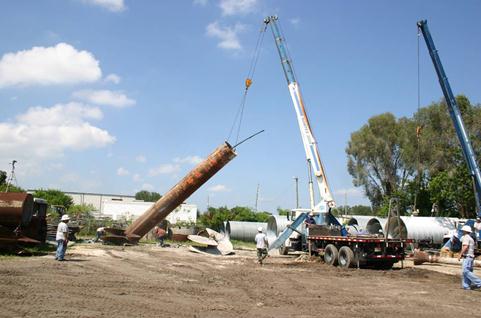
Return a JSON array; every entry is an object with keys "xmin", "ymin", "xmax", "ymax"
[{"xmin": 227, "ymin": 25, "xmax": 267, "ymax": 144}]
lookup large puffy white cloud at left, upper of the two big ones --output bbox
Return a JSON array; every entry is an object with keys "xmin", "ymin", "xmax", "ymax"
[{"xmin": 0, "ymin": 43, "xmax": 102, "ymax": 88}]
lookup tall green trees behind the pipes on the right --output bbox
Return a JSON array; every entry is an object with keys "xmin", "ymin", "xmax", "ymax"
[{"xmin": 346, "ymin": 95, "xmax": 481, "ymax": 218}]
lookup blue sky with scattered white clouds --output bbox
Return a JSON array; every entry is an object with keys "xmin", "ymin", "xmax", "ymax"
[{"xmin": 0, "ymin": 0, "xmax": 481, "ymax": 211}]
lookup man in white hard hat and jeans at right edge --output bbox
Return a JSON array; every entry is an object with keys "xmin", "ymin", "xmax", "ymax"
[{"xmin": 458, "ymin": 225, "xmax": 481, "ymax": 289}]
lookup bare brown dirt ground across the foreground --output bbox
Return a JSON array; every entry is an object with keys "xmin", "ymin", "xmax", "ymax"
[{"xmin": 0, "ymin": 244, "xmax": 481, "ymax": 318}]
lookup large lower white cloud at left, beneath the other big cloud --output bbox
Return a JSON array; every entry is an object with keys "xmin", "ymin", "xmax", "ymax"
[{"xmin": 0, "ymin": 103, "xmax": 115, "ymax": 162}]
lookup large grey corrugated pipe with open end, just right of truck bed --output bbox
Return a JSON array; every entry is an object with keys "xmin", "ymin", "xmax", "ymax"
[{"xmin": 385, "ymin": 216, "xmax": 456, "ymax": 244}]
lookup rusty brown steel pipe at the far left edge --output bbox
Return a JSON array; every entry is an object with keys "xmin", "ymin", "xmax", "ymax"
[{"xmin": 0, "ymin": 192, "xmax": 33, "ymax": 227}]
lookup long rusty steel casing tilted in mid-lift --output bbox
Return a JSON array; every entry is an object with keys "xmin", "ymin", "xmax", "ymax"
[{"xmin": 125, "ymin": 142, "xmax": 236, "ymax": 241}]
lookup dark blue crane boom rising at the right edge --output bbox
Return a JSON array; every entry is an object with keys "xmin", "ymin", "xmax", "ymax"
[{"xmin": 417, "ymin": 20, "xmax": 481, "ymax": 217}]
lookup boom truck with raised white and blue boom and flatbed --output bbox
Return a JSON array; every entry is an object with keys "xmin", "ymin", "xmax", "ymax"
[{"xmin": 264, "ymin": 16, "xmax": 410, "ymax": 268}]
